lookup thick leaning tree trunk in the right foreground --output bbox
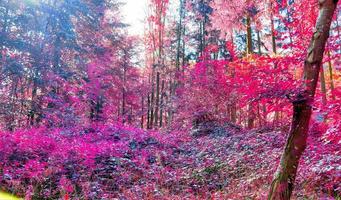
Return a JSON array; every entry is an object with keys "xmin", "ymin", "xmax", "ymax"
[{"xmin": 268, "ymin": 0, "xmax": 338, "ymax": 200}]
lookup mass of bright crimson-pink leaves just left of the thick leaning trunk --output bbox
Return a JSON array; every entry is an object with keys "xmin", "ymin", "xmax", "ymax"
[{"xmin": 179, "ymin": 53, "xmax": 299, "ymax": 127}]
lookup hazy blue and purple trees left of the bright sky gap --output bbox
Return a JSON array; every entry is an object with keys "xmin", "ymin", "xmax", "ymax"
[{"xmin": 1, "ymin": 1, "xmax": 140, "ymax": 130}]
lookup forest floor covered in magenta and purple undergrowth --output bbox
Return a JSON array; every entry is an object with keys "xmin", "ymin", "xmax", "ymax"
[{"xmin": 0, "ymin": 122, "xmax": 341, "ymax": 199}]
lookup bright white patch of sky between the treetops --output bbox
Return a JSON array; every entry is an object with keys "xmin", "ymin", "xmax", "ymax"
[{"xmin": 122, "ymin": 0, "xmax": 148, "ymax": 35}]
